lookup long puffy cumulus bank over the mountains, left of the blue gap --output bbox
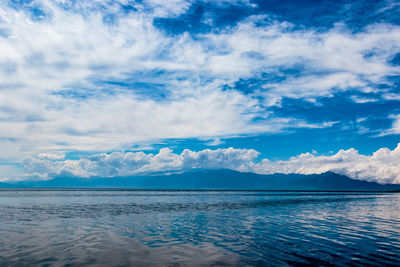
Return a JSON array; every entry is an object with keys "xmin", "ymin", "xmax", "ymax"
[{"xmin": 23, "ymin": 148, "xmax": 259, "ymax": 179}]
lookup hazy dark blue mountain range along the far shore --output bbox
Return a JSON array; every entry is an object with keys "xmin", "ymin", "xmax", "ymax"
[{"xmin": 0, "ymin": 169, "xmax": 400, "ymax": 191}]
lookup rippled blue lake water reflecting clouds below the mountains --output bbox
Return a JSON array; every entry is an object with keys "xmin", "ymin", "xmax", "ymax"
[{"xmin": 0, "ymin": 190, "xmax": 400, "ymax": 266}]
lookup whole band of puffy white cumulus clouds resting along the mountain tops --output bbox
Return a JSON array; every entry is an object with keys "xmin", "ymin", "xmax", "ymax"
[{"xmin": 14, "ymin": 143, "xmax": 400, "ymax": 184}]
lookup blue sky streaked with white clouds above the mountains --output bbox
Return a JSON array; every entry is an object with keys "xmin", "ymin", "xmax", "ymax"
[{"xmin": 0, "ymin": 0, "xmax": 400, "ymax": 183}]
